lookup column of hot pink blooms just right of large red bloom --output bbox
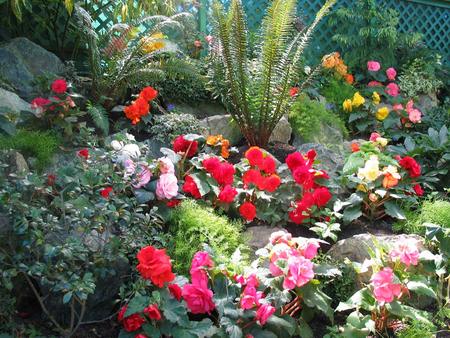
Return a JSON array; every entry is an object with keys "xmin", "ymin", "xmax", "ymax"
[{"xmin": 182, "ymin": 251, "xmax": 216, "ymax": 314}]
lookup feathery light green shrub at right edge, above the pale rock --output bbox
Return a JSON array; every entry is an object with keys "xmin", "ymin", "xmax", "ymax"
[{"xmin": 393, "ymin": 200, "xmax": 450, "ymax": 235}]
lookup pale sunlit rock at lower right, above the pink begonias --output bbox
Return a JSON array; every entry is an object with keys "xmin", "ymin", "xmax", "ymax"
[{"xmin": 328, "ymin": 234, "xmax": 425, "ymax": 263}]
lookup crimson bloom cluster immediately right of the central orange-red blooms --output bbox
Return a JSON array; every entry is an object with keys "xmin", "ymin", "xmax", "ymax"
[{"xmin": 286, "ymin": 150, "xmax": 332, "ymax": 224}]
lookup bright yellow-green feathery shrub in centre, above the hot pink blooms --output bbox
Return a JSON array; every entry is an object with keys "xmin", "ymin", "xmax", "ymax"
[{"xmin": 169, "ymin": 200, "xmax": 245, "ymax": 274}]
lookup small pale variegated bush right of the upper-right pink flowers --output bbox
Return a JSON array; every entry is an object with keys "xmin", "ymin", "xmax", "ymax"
[{"xmin": 398, "ymin": 58, "xmax": 443, "ymax": 98}]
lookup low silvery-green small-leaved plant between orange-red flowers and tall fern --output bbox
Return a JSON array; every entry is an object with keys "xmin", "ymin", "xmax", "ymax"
[{"xmin": 150, "ymin": 112, "xmax": 203, "ymax": 143}]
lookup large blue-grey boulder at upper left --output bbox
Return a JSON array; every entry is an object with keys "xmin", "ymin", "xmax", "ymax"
[{"xmin": 0, "ymin": 38, "xmax": 64, "ymax": 101}]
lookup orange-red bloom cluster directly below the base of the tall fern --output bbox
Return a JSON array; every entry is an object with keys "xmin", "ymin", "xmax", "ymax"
[{"xmin": 242, "ymin": 147, "xmax": 281, "ymax": 192}]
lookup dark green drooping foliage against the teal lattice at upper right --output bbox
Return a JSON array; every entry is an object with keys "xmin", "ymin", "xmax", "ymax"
[{"xmin": 328, "ymin": 0, "xmax": 421, "ymax": 73}]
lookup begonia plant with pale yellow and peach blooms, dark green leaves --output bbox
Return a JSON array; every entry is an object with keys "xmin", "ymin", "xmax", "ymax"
[{"xmin": 334, "ymin": 137, "xmax": 423, "ymax": 223}]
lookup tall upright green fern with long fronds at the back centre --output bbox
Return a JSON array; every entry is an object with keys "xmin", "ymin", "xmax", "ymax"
[{"xmin": 212, "ymin": 0, "xmax": 335, "ymax": 147}]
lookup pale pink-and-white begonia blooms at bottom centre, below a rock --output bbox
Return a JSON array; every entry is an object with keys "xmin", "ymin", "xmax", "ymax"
[{"xmin": 269, "ymin": 231, "xmax": 320, "ymax": 290}]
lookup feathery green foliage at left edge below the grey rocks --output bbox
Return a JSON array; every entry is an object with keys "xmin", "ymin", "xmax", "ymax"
[{"xmin": 0, "ymin": 130, "xmax": 60, "ymax": 171}]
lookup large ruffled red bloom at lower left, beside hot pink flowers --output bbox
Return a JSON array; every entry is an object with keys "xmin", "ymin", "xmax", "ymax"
[{"xmin": 137, "ymin": 245, "xmax": 175, "ymax": 288}]
